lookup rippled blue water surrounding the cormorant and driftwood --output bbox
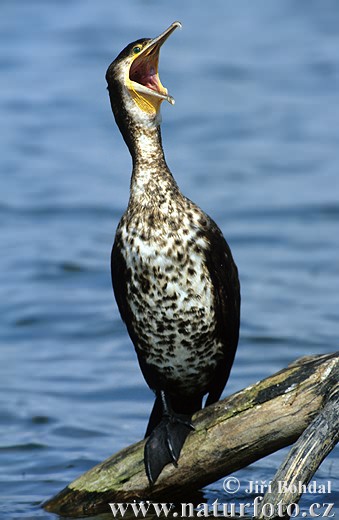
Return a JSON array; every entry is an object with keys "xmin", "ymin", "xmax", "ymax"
[{"xmin": 0, "ymin": 0, "xmax": 339, "ymax": 520}]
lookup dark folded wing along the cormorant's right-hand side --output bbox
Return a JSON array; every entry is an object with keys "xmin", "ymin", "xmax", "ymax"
[{"xmin": 205, "ymin": 219, "xmax": 240, "ymax": 406}]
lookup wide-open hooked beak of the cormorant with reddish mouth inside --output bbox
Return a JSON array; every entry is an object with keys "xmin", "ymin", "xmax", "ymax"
[{"xmin": 129, "ymin": 22, "xmax": 181, "ymax": 110}]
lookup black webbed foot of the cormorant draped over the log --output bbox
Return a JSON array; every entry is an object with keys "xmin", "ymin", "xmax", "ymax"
[{"xmin": 144, "ymin": 410, "xmax": 194, "ymax": 484}]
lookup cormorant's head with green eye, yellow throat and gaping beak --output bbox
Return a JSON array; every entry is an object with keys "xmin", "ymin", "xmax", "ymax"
[{"xmin": 106, "ymin": 22, "xmax": 181, "ymax": 119}]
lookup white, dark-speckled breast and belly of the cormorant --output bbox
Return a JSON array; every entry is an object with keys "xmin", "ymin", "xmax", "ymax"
[{"xmin": 118, "ymin": 203, "xmax": 223, "ymax": 394}]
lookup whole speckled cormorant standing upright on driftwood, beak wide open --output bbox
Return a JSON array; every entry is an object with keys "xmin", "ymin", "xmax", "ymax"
[{"xmin": 106, "ymin": 22, "xmax": 240, "ymax": 486}]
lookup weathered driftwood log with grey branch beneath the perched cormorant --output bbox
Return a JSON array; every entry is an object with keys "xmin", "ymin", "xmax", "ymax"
[{"xmin": 44, "ymin": 353, "xmax": 339, "ymax": 518}]
